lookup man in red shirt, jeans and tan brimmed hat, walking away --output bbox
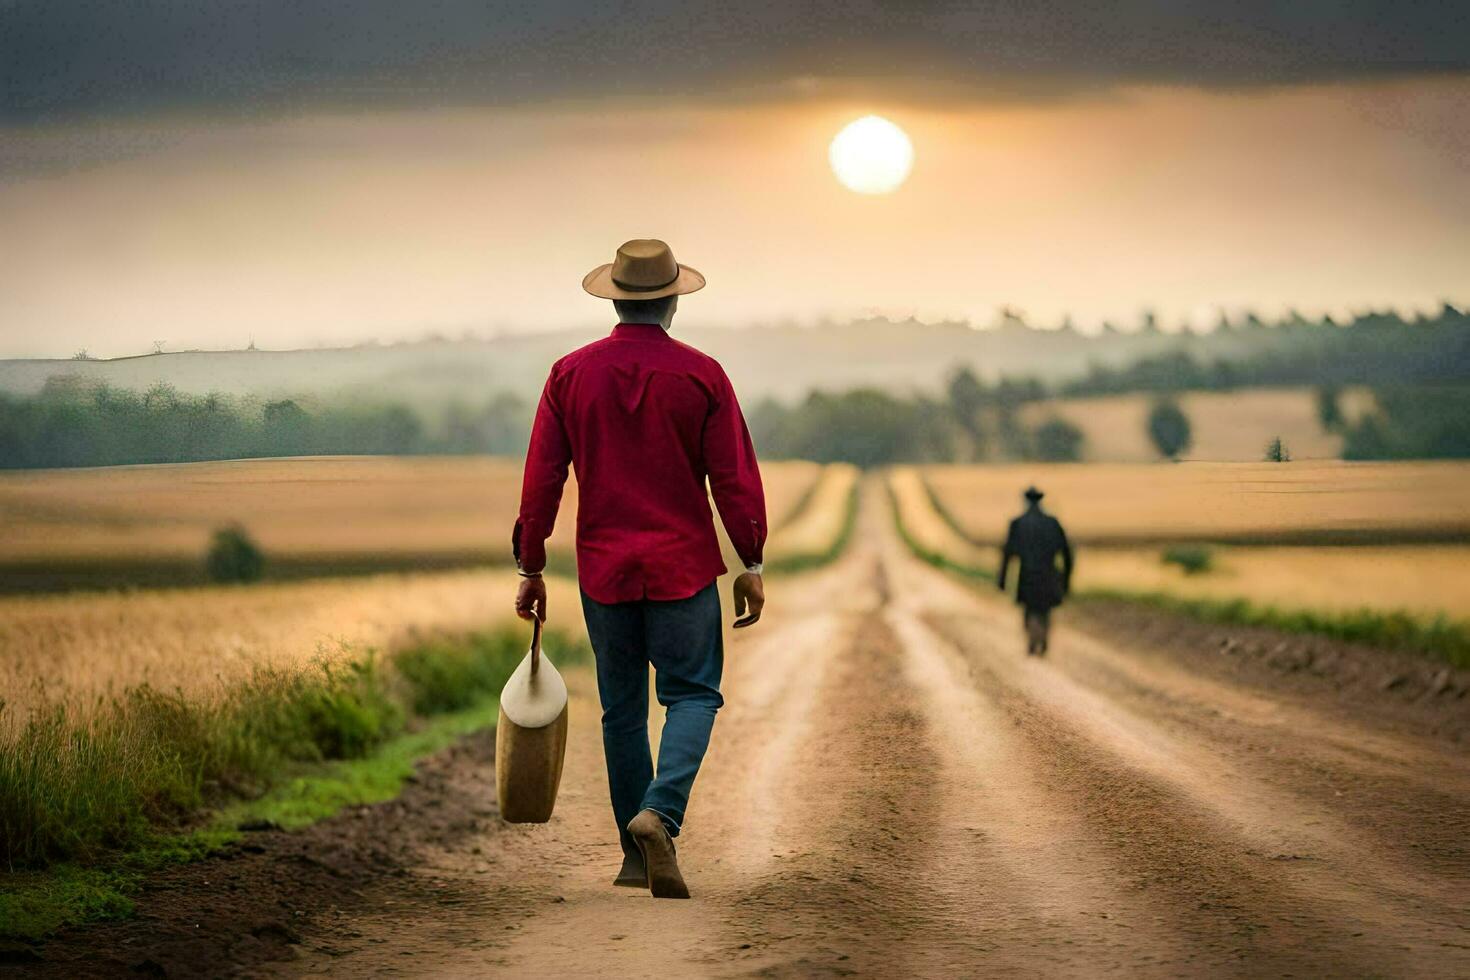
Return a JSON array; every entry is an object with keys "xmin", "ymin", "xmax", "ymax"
[{"xmin": 512, "ymin": 239, "xmax": 766, "ymax": 898}]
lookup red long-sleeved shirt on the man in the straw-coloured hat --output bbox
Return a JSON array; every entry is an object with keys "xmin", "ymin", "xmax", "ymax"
[{"xmin": 512, "ymin": 323, "xmax": 766, "ymax": 602}]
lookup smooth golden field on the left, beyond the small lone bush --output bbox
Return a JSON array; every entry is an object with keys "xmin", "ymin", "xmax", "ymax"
[{"xmin": 0, "ymin": 457, "xmax": 819, "ymax": 563}]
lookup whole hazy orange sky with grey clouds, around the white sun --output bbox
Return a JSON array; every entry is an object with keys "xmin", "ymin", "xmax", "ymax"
[{"xmin": 0, "ymin": 0, "xmax": 1470, "ymax": 354}]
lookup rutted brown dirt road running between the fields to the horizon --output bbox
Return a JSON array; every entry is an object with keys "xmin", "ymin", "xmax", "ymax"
[{"xmin": 238, "ymin": 486, "xmax": 1470, "ymax": 977}]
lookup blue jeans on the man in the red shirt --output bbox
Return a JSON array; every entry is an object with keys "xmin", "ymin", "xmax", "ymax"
[{"xmin": 582, "ymin": 582, "xmax": 725, "ymax": 854}]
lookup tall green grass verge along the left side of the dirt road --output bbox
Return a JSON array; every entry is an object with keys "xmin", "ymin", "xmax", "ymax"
[{"xmin": 0, "ymin": 630, "xmax": 587, "ymax": 940}]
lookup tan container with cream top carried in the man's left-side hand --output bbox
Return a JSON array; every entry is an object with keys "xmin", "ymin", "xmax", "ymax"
[{"xmin": 495, "ymin": 620, "xmax": 566, "ymax": 823}]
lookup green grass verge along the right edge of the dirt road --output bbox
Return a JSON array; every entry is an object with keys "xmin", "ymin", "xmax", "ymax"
[{"xmin": 889, "ymin": 482, "xmax": 1470, "ymax": 669}]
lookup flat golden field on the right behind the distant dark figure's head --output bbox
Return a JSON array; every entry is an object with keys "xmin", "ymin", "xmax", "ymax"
[{"xmin": 923, "ymin": 461, "xmax": 1470, "ymax": 544}]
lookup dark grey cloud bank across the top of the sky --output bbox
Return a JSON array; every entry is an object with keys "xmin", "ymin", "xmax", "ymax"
[{"xmin": 0, "ymin": 0, "xmax": 1470, "ymax": 122}]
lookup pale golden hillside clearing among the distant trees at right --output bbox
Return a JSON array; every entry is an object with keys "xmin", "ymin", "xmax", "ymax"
[{"xmin": 1022, "ymin": 388, "xmax": 1373, "ymax": 463}]
